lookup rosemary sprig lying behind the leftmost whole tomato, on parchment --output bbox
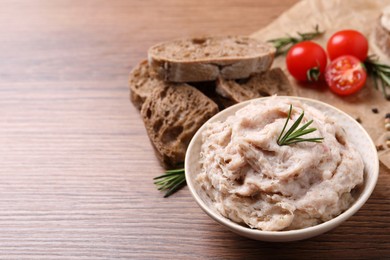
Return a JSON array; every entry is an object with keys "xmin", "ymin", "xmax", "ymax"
[{"xmin": 268, "ymin": 24, "xmax": 325, "ymax": 56}]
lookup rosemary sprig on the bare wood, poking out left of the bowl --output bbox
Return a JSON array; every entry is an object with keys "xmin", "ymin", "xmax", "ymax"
[{"xmin": 153, "ymin": 168, "xmax": 186, "ymax": 198}]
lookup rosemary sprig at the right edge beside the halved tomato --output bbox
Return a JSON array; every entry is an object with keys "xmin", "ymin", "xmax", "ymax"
[{"xmin": 364, "ymin": 55, "xmax": 390, "ymax": 100}]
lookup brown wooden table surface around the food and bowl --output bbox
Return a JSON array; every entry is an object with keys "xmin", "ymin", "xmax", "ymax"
[{"xmin": 0, "ymin": 0, "xmax": 390, "ymax": 259}]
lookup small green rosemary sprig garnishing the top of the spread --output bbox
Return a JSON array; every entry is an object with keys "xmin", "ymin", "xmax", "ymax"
[{"xmin": 277, "ymin": 105, "xmax": 324, "ymax": 146}]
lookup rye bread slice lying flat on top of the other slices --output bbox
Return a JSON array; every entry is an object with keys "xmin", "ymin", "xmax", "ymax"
[{"xmin": 148, "ymin": 36, "xmax": 276, "ymax": 82}]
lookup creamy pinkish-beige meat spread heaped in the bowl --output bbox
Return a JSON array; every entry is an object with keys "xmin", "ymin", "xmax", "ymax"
[{"xmin": 196, "ymin": 99, "xmax": 364, "ymax": 231}]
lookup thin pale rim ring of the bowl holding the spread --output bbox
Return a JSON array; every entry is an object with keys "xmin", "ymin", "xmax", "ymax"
[{"xmin": 184, "ymin": 96, "xmax": 379, "ymax": 238}]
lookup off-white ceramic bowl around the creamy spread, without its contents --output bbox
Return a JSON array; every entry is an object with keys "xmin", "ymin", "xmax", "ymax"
[{"xmin": 185, "ymin": 97, "xmax": 379, "ymax": 242}]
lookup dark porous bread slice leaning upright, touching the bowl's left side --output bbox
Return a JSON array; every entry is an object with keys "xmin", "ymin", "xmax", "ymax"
[{"xmin": 141, "ymin": 83, "xmax": 218, "ymax": 168}]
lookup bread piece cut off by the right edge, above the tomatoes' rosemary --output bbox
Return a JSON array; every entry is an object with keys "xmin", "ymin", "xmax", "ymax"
[{"xmin": 375, "ymin": 12, "xmax": 390, "ymax": 57}]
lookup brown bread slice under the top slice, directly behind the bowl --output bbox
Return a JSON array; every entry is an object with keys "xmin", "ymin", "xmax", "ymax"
[{"xmin": 216, "ymin": 68, "xmax": 293, "ymax": 103}]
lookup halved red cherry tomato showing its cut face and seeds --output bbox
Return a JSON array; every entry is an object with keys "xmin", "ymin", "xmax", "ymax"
[{"xmin": 325, "ymin": 55, "xmax": 367, "ymax": 96}]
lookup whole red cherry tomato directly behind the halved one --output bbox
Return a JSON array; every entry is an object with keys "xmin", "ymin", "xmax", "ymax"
[{"xmin": 326, "ymin": 30, "xmax": 368, "ymax": 61}]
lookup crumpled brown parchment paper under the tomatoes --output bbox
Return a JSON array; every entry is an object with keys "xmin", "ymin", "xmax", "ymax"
[{"xmin": 251, "ymin": 0, "xmax": 390, "ymax": 169}]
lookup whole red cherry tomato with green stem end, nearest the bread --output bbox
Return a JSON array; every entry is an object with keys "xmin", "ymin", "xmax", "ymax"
[{"xmin": 286, "ymin": 41, "xmax": 327, "ymax": 81}]
